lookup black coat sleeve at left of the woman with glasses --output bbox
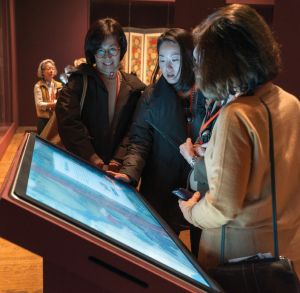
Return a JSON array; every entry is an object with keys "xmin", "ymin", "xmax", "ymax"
[{"xmin": 55, "ymin": 74, "xmax": 95, "ymax": 160}]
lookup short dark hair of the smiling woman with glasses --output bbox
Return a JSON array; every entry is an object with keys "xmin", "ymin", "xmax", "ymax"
[{"xmin": 84, "ymin": 18, "xmax": 127, "ymax": 65}]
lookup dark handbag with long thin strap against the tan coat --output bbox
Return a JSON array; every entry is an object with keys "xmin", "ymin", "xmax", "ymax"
[{"xmin": 208, "ymin": 100, "xmax": 300, "ymax": 293}]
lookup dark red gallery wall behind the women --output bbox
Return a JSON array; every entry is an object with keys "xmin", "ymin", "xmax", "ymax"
[{"xmin": 15, "ymin": 0, "xmax": 300, "ymax": 125}]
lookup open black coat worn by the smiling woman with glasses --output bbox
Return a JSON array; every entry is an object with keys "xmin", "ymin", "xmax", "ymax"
[{"xmin": 55, "ymin": 64, "xmax": 145, "ymax": 164}]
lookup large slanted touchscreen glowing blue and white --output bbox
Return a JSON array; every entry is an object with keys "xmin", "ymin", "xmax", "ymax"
[{"xmin": 15, "ymin": 134, "xmax": 220, "ymax": 288}]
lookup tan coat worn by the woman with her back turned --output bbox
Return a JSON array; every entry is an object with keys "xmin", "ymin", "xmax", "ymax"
[{"xmin": 188, "ymin": 83, "xmax": 300, "ymax": 276}]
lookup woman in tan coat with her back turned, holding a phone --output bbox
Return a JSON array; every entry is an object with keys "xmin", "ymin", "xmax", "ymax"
[{"xmin": 179, "ymin": 4, "xmax": 300, "ymax": 275}]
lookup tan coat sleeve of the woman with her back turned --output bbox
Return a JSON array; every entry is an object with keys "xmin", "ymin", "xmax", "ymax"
[{"xmin": 188, "ymin": 109, "xmax": 252, "ymax": 229}]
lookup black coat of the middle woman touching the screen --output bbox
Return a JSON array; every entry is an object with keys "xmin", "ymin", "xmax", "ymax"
[{"xmin": 121, "ymin": 77, "xmax": 205, "ymax": 233}]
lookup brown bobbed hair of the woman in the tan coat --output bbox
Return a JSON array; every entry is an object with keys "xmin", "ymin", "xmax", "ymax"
[{"xmin": 193, "ymin": 4, "xmax": 281, "ymax": 99}]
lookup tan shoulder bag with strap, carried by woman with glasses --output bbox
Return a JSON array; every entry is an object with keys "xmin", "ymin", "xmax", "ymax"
[{"xmin": 40, "ymin": 74, "xmax": 88, "ymax": 148}]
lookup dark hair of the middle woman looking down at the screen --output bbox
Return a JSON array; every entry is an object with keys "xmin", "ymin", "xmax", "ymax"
[{"xmin": 157, "ymin": 28, "xmax": 195, "ymax": 88}]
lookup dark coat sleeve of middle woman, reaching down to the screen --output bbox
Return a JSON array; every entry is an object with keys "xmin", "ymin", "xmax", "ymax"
[{"xmin": 120, "ymin": 90, "xmax": 153, "ymax": 185}]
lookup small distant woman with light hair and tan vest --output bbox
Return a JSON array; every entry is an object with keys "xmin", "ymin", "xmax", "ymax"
[{"xmin": 33, "ymin": 59, "xmax": 62, "ymax": 134}]
